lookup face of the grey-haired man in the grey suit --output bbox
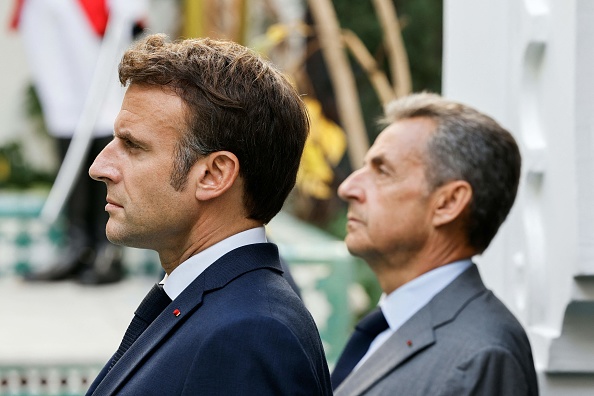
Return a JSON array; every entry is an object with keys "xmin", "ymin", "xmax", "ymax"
[{"xmin": 338, "ymin": 118, "xmax": 435, "ymax": 263}]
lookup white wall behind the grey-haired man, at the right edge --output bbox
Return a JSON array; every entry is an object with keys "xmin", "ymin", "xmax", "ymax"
[{"xmin": 443, "ymin": 0, "xmax": 594, "ymax": 395}]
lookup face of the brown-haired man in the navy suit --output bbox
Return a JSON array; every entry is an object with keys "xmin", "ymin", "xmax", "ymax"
[{"xmin": 89, "ymin": 84, "xmax": 197, "ymax": 251}]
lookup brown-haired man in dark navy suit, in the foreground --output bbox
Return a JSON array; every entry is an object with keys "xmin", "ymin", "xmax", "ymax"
[{"xmin": 88, "ymin": 35, "xmax": 332, "ymax": 395}]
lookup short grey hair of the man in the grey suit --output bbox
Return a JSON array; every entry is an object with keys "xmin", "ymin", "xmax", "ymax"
[{"xmin": 382, "ymin": 92, "xmax": 522, "ymax": 253}]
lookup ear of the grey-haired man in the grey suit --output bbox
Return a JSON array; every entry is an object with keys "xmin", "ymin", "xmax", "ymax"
[{"xmin": 433, "ymin": 180, "xmax": 472, "ymax": 227}]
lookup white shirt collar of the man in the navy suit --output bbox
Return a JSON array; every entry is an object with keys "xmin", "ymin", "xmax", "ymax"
[{"xmin": 160, "ymin": 227, "xmax": 267, "ymax": 300}]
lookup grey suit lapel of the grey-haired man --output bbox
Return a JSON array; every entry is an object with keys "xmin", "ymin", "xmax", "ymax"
[{"xmin": 335, "ymin": 265, "xmax": 486, "ymax": 396}]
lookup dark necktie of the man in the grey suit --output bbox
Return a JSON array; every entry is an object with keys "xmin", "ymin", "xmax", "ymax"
[{"xmin": 331, "ymin": 308, "xmax": 389, "ymax": 390}]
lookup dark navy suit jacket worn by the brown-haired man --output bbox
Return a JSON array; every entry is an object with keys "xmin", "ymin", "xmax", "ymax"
[{"xmin": 87, "ymin": 243, "xmax": 332, "ymax": 396}]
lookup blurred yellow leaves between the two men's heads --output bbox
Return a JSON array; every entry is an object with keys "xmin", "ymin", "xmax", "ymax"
[{"xmin": 297, "ymin": 98, "xmax": 346, "ymax": 199}]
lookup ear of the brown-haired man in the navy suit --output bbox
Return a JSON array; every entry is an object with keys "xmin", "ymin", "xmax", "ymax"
[{"xmin": 196, "ymin": 151, "xmax": 239, "ymax": 201}]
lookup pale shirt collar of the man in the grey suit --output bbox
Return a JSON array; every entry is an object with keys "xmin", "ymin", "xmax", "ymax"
[{"xmin": 379, "ymin": 259, "xmax": 472, "ymax": 331}]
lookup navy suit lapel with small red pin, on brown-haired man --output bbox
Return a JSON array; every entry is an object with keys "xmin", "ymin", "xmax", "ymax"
[{"xmin": 94, "ymin": 243, "xmax": 282, "ymax": 395}]
